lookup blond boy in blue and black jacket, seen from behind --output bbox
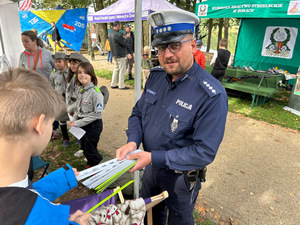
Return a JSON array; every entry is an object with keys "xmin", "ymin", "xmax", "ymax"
[{"xmin": 0, "ymin": 68, "xmax": 90, "ymax": 225}]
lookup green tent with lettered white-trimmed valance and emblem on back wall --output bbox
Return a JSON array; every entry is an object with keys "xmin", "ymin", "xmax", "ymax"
[{"xmin": 195, "ymin": 0, "xmax": 300, "ymax": 73}]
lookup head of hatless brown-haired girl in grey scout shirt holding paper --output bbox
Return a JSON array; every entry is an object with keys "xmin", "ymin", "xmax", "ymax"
[{"xmin": 76, "ymin": 62, "xmax": 98, "ymax": 86}]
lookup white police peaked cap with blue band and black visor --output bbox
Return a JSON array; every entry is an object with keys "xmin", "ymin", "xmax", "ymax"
[{"xmin": 147, "ymin": 10, "xmax": 200, "ymax": 47}]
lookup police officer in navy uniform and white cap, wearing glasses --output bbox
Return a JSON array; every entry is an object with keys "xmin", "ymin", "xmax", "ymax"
[{"xmin": 116, "ymin": 10, "xmax": 228, "ymax": 225}]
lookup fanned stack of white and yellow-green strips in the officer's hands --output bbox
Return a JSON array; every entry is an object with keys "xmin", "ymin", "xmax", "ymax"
[{"xmin": 76, "ymin": 149, "xmax": 141, "ymax": 193}]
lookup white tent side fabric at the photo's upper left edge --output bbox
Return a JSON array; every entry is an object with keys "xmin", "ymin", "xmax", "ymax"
[{"xmin": 0, "ymin": 0, "xmax": 24, "ymax": 72}]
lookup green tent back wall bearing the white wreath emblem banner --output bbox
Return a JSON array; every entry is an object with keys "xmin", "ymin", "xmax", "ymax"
[{"xmin": 234, "ymin": 18, "xmax": 300, "ymax": 73}]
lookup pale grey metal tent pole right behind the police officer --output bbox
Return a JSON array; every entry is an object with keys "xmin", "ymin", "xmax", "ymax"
[{"xmin": 134, "ymin": 0, "xmax": 142, "ymax": 198}]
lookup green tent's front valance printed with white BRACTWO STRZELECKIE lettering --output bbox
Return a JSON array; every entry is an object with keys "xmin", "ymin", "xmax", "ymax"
[{"xmin": 195, "ymin": 0, "xmax": 300, "ymax": 18}]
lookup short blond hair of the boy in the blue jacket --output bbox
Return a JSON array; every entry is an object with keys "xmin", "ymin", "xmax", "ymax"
[{"xmin": 0, "ymin": 68, "xmax": 66, "ymax": 140}]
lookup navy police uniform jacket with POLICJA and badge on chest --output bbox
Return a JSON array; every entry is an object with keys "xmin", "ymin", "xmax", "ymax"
[{"xmin": 126, "ymin": 63, "xmax": 228, "ymax": 171}]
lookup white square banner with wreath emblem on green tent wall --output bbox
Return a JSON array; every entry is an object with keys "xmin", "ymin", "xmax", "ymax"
[{"xmin": 261, "ymin": 26, "xmax": 298, "ymax": 59}]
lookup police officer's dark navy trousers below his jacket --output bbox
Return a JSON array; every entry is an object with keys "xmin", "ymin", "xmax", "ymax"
[{"xmin": 141, "ymin": 165, "xmax": 201, "ymax": 225}]
